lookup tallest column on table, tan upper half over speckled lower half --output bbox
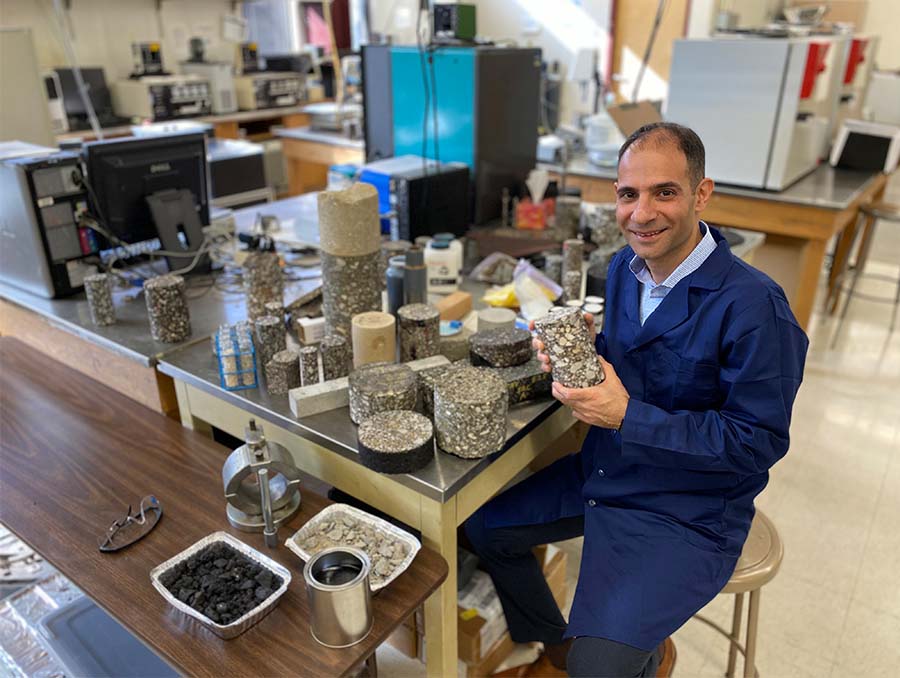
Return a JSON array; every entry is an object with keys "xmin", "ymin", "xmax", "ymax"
[{"xmin": 318, "ymin": 183, "xmax": 383, "ymax": 337}]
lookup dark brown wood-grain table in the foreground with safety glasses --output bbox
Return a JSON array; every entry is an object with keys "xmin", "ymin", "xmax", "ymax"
[{"xmin": 0, "ymin": 337, "xmax": 455, "ymax": 676}]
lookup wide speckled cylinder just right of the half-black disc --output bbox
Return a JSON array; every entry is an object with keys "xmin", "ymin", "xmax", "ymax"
[{"xmin": 434, "ymin": 367, "xmax": 509, "ymax": 459}]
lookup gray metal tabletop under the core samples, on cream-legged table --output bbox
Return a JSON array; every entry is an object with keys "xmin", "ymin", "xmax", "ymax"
[{"xmin": 158, "ymin": 344, "xmax": 560, "ymax": 501}]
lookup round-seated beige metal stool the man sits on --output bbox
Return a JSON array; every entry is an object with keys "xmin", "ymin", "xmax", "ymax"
[{"xmin": 694, "ymin": 510, "xmax": 784, "ymax": 678}]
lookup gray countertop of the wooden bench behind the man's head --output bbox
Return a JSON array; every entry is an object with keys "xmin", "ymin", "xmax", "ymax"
[{"xmin": 542, "ymin": 155, "xmax": 876, "ymax": 210}]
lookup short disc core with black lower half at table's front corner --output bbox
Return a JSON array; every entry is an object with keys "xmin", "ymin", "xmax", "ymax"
[{"xmin": 357, "ymin": 410, "xmax": 434, "ymax": 473}]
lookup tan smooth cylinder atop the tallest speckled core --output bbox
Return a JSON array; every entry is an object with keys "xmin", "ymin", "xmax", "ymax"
[{"xmin": 319, "ymin": 183, "xmax": 381, "ymax": 258}]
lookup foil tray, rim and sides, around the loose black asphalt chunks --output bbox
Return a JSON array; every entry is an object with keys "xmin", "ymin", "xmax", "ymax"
[{"xmin": 150, "ymin": 532, "xmax": 291, "ymax": 640}]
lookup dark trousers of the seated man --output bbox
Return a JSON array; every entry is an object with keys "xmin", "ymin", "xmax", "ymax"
[{"xmin": 465, "ymin": 511, "xmax": 661, "ymax": 678}]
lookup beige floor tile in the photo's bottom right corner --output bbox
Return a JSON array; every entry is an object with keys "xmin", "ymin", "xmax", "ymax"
[{"xmin": 832, "ymin": 601, "xmax": 900, "ymax": 678}]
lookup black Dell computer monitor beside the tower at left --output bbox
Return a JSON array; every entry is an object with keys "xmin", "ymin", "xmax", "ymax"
[{"xmin": 84, "ymin": 132, "xmax": 209, "ymax": 270}]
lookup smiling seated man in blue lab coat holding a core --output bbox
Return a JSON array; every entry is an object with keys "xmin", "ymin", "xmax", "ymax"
[{"xmin": 466, "ymin": 123, "xmax": 808, "ymax": 677}]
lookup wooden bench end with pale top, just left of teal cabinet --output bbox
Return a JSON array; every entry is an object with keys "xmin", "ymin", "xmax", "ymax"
[{"xmin": 275, "ymin": 127, "xmax": 365, "ymax": 195}]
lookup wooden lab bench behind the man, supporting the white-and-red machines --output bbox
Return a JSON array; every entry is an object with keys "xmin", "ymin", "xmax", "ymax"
[{"xmin": 557, "ymin": 158, "xmax": 888, "ymax": 329}]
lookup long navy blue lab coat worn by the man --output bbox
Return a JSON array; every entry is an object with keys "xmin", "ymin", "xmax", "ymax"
[{"xmin": 484, "ymin": 229, "xmax": 808, "ymax": 650}]
